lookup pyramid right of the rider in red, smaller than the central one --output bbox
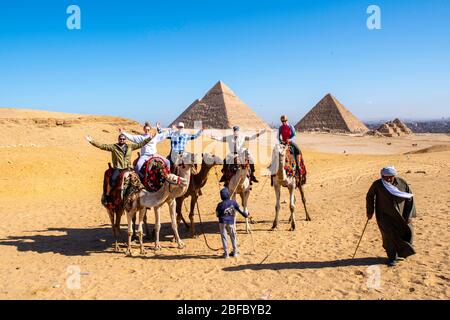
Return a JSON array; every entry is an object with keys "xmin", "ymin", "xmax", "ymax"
[{"xmin": 295, "ymin": 94, "xmax": 369, "ymax": 133}]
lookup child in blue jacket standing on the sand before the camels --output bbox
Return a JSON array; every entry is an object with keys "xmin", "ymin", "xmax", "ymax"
[{"xmin": 216, "ymin": 188, "xmax": 248, "ymax": 258}]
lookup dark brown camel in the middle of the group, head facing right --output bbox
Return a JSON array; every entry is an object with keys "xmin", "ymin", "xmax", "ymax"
[{"xmin": 176, "ymin": 153, "xmax": 223, "ymax": 238}]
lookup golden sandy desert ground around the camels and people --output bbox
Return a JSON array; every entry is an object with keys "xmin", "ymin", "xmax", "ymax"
[{"xmin": 0, "ymin": 109, "xmax": 450, "ymax": 299}]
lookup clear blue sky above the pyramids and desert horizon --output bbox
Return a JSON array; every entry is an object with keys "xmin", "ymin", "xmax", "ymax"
[{"xmin": 0, "ymin": 0, "xmax": 450, "ymax": 124}]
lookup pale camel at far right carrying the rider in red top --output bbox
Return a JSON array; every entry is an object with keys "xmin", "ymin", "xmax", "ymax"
[{"xmin": 269, "ymin": 144, "xmax": 311, "ymax": 231}]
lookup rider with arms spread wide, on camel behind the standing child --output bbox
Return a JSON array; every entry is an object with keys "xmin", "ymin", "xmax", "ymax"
[{"xmin": 211, "ymin": 126, "xmax": 266, "ymax": 183}]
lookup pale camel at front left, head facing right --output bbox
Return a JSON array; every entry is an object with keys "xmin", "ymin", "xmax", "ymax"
[{"xmin": 124, "ymin": 171, "xmax": 189, "ymax": 255}]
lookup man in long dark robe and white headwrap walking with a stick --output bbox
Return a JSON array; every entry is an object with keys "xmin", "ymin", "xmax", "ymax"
[{"xmin": 366, "ymin": 167, "xmax": 416, "ymax": 266}]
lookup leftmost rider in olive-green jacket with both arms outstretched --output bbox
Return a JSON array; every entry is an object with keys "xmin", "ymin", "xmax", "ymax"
[{"xmin": 85, "ymin": 134, "xmax": 152, "ymax": 202}]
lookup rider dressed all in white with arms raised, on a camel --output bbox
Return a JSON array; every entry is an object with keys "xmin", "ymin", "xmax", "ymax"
[{"xmin": 119, "ymin": 122, "xmax": 172, "ymax": 179}]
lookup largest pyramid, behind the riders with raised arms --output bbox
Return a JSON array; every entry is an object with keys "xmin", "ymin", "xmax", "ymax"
[{"xmin": 170, "ymin": 81, "xmax": 270, "ymax": 130}]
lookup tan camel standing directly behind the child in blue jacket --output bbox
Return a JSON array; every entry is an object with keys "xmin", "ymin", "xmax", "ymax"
[{"xmin": 227, "ymin": 153, "xmax": 255, "ymax": 233}]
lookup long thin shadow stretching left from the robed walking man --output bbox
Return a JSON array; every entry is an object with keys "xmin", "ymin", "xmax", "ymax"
[{"xmin": 222, "ymin": 257, "xmax": 386, "ymax": 271}]
